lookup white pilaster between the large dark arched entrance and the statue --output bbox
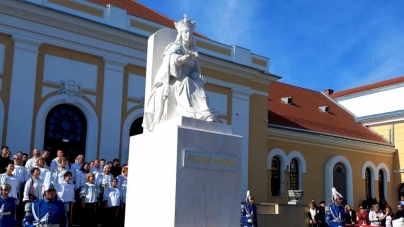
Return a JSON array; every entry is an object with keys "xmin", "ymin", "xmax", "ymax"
[{"xmin": 100, "ymin": 58, "xmax": 126, "ymax": 161}]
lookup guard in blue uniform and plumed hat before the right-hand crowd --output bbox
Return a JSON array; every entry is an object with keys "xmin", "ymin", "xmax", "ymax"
[{"xmin": 325, "ymin": 188, "xmax": 345, "ymax": 227}]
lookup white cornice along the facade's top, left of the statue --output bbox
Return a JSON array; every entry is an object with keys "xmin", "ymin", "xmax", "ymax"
[{"xmin": 0, "ymin": 1, "xmax": 147, "ymax": 51}]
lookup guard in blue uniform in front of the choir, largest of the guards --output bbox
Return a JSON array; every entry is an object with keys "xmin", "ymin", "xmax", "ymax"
[{"xmin": 22, "ymin": 183, "xmax": 67, "ymax": 227}]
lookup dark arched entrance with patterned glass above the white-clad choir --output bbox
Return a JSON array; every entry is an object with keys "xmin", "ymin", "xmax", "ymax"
[{"xmin": 44, "ymin": 104, "xmax": 87, "ymax": 163}]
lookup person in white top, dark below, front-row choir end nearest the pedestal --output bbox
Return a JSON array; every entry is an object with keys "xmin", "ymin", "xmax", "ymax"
[{"xmin": 104, "ymin": 179, "xmax": 121, "ymax": 226}]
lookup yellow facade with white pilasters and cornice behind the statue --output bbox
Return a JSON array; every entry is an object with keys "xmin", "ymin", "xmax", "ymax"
[{"xmin": 0, "ymin": 0, "xmax": 279, "ymax": 199}]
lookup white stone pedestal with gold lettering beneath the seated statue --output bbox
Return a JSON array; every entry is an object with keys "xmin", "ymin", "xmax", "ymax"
[{"xmin": 125, "ymin": 117, "xmax": 242, "ymax": 227}]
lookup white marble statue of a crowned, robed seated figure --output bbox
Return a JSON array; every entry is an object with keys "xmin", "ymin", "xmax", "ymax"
[{"xmin": 143, "ymin": 15, "xmax": 216, "ymax": 131}]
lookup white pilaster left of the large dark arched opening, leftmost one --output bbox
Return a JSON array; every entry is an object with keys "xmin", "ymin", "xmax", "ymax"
[{"xmin": 6, "ymin": 35, "xmax": 41, "ymax": 152}]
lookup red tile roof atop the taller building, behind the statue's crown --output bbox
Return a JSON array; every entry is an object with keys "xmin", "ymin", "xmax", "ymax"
[{"xmin": 87, "ymin": 0, "xmax": 207, "ymax": 38}]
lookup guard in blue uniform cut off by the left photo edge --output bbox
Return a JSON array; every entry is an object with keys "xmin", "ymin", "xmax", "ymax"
[{"xmin": 0, "ymin": 184, "xmax": 17, "ymax": 227}]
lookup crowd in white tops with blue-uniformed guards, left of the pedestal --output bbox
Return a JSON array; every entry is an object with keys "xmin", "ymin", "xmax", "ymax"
[{"xmin": 0, "ymin": 146, "xmax": 128, "ymax": 227}]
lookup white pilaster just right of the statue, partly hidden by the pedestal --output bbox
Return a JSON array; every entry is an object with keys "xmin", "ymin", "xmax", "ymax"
[{"xmin": 231, "ymin": 88, "xmax": 252, "ymax": 201}]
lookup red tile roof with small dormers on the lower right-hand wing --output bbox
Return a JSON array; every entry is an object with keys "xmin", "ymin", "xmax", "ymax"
[{"xmin": 268, "ymin": 82, "xmax": 389, "ymax": 145}]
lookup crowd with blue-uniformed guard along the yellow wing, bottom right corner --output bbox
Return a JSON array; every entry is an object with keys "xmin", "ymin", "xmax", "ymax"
[{"xmin": 308, "ymin": 193, "xmax": 404, "ymax": 227}]
